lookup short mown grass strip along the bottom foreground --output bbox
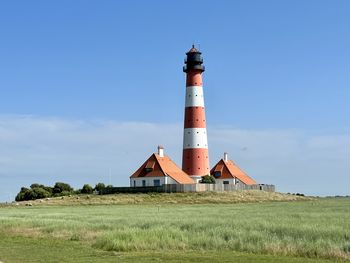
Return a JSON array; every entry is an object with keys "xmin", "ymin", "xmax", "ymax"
[{"xmin": 0, "ymin": 237, "xmax": 333, "ymax": 263}]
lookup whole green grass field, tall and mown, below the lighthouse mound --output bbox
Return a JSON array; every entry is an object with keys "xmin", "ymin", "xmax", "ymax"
[{"xmin": 0, "ymin": 193, "xmax": 350, "ymax": 263}]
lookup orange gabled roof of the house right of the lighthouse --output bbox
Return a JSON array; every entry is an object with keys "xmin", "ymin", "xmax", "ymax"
[{"xmin": 210, "ymin": 159, "xmax": 257, "ymax": 185}]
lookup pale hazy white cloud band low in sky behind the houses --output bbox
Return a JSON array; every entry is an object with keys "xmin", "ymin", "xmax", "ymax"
[{"xmin": 0, "ymin": 115, "xmax": 350, "ymax": 200}]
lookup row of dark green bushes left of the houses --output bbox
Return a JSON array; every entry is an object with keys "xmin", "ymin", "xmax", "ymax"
[{"xmin": 16, "ymin": 182, "xmax": 113, "ymax": 201}]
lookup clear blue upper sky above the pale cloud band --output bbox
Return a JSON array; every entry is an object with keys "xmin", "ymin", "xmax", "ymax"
[{"xmin": 0, "ymin": 0, "xmax": 350, "ymax": 202}]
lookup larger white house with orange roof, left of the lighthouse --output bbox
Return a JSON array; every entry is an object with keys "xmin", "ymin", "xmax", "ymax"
[{"xmin": 130, "ymin": 146, "xmax": 195, "ymax": 187}]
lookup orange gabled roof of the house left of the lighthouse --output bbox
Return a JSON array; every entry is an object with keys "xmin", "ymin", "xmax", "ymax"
[{"xmin": 130, "ymin": 153, "xmax": 195, "ymax": 184}]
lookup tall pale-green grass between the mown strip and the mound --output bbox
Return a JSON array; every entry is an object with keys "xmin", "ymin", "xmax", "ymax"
[{"xmin": 0, "ymin": 198, "xmax": 350, "ymax": 260}]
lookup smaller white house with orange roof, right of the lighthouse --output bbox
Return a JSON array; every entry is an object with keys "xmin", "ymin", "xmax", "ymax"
[{"xmin": 210, "ymin": 153, "xmax": 257, "ymax": 185}]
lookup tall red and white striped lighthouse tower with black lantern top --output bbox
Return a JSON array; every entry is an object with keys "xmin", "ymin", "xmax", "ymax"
[{"xmin": 182, "ymin": 45, "xmax": 210, "ymax": 182}]
